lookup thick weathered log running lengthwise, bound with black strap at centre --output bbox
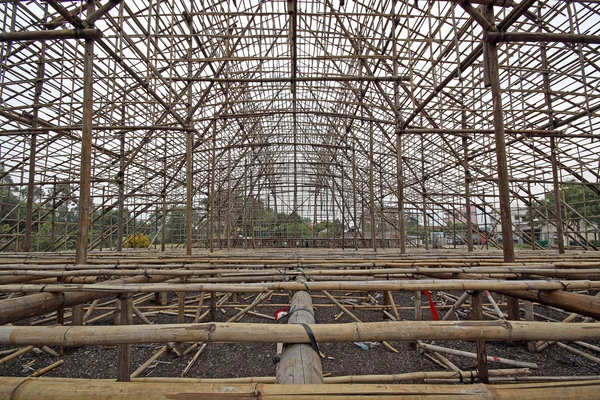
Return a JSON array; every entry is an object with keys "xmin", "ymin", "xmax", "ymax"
[{"xmin": 275, "ymin": 277, "xmax": 323, "ymax": 384}]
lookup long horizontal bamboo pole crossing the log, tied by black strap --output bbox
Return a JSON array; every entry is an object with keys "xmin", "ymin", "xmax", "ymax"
[{"xmin": 0, "ymin": 321, "xmax": 600, "ymax": 346}]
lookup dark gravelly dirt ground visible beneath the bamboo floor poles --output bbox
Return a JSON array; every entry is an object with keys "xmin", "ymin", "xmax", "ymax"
[{"xmin": 0, "ymin": 292, "xmax": 600, "ymax": 383}]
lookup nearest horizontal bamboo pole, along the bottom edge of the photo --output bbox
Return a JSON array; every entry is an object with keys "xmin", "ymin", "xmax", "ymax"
[{"xmin": 0, "ymin": 377, "xmax": 600, "ymax": 400}]
